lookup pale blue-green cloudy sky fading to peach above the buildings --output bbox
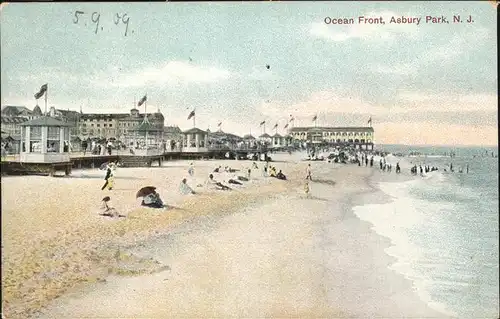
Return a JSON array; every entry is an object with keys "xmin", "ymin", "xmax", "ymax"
[{"xmin": 0, "ymin": 1, "xmax": 498, "ymax": 146}]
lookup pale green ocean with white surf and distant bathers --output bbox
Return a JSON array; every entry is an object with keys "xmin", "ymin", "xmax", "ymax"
[{"xmin": 354, "ymin": 145, "xmax": 499, "ymax": 318}]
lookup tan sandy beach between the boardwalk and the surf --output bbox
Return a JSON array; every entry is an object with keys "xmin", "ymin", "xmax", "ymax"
[{"xmin": 2, "ymin": 154, "xmax": 443, "ymax": 318}]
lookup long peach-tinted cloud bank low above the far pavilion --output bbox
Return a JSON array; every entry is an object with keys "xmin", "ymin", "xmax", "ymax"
[{"xmin": 256, "ymin": 90, "xmax": 498, "ymax": 126}]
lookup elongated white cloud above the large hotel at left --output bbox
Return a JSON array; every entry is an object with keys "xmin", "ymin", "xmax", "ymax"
[{"xmin": 97, "ymin": 61, "xmax": 231, "ymax": 88}]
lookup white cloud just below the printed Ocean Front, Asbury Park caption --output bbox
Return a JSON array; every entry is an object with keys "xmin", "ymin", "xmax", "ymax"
[{"xmin": 310, "ymin": 11, "xmax": 418, "ymax": 42}]
